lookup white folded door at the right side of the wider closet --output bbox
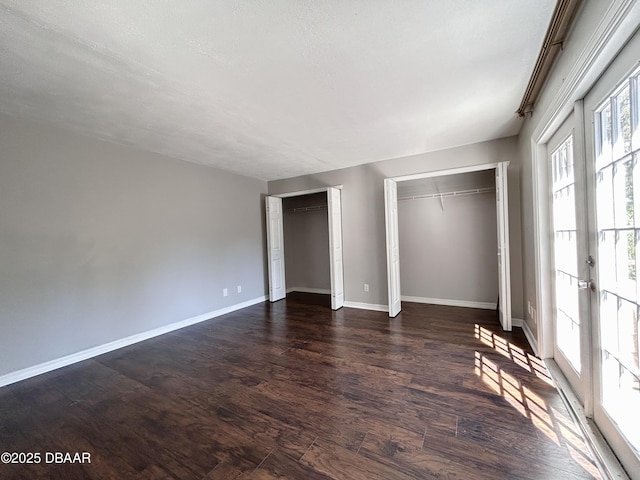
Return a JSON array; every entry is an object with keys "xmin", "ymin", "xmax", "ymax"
[{"xmin": 496, "ymin": 162, "xmax": 511, "ymax": 332}]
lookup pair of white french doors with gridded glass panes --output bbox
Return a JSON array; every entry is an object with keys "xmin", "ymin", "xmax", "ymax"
[{"xmin": 547, "ymin": 35, "xmax": 640, "ymax": 479}]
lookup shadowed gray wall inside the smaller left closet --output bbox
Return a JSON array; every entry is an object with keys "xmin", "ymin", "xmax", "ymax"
[{"xmin": 283, "ymin": 192, "xmax": 331, "ymax": 290}]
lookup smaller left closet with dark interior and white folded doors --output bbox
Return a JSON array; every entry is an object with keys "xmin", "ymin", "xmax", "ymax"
[{"xmin": 266, "ymin": 187, "xmax": 344, "ymax": 310}]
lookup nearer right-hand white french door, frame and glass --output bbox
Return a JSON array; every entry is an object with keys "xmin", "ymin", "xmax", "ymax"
[{"xmin": 584, "ymin": 38, "xmax": 640, "ymax": 479}]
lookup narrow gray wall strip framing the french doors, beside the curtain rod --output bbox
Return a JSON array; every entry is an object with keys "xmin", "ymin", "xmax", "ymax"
[{"xmin": 518, "ymin": 0, "xmax": 624, "ymax": 342}]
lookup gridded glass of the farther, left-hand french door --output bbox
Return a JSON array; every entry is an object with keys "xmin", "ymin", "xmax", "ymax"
[{"xmin": 551, "ymin": 137, "xmax": 584, "ymax": 373}]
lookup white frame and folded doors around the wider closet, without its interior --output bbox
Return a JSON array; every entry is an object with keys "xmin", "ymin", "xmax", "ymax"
[{"xmin": 384, "ymin": 162, "xmax": 512, "ymax": 331}]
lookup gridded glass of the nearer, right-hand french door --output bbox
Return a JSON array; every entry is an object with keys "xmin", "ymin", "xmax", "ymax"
[{"xmin": 595, "ymin": 72, "xmax": 640, "ymax": 452}]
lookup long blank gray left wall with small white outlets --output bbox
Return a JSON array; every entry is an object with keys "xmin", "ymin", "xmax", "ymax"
[{"xmin": 0, "ymin": 116, "xmax": 267, "ymax": 375}]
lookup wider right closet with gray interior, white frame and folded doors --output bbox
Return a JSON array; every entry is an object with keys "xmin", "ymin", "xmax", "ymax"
[{"xmin": 384, "ymin": 162, "xmax": 511, "ymax": 331}]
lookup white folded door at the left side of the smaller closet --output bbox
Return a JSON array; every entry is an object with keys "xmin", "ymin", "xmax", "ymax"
[{"xmin": 266, "ymin": 197, "xmax": 287, "ymax": 302}]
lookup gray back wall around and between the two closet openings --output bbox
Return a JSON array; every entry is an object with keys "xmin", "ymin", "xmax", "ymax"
[{"xmin": 269, "ymin": 137, "xmax": 523, "ymax": 318}]
